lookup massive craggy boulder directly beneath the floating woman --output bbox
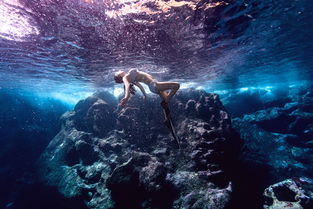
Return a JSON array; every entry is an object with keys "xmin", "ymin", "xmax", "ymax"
[{"xmin": 39, "ymin": 90, "xmax": 242, "ymax": 209}]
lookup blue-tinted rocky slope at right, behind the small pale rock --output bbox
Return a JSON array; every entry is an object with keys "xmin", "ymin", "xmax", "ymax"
[{"xmin": 233, "ymin": 87, "xmax": 313, "ymax": 181}]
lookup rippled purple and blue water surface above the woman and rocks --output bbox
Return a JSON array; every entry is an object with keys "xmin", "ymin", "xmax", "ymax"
[{"xmin": 0, "ymin": 0, "xmax": 313, "ymax": 100}]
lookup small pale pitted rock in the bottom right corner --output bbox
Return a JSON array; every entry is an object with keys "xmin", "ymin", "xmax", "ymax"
[{"xmin": 263, "ymin": 177, "xmax": 313, "ymax": 209}]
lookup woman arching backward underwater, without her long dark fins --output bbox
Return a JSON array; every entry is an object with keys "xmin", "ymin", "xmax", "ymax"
[{"xmin": 114, "ymin": 69, "xmax": 180, "ymax": 107}]
